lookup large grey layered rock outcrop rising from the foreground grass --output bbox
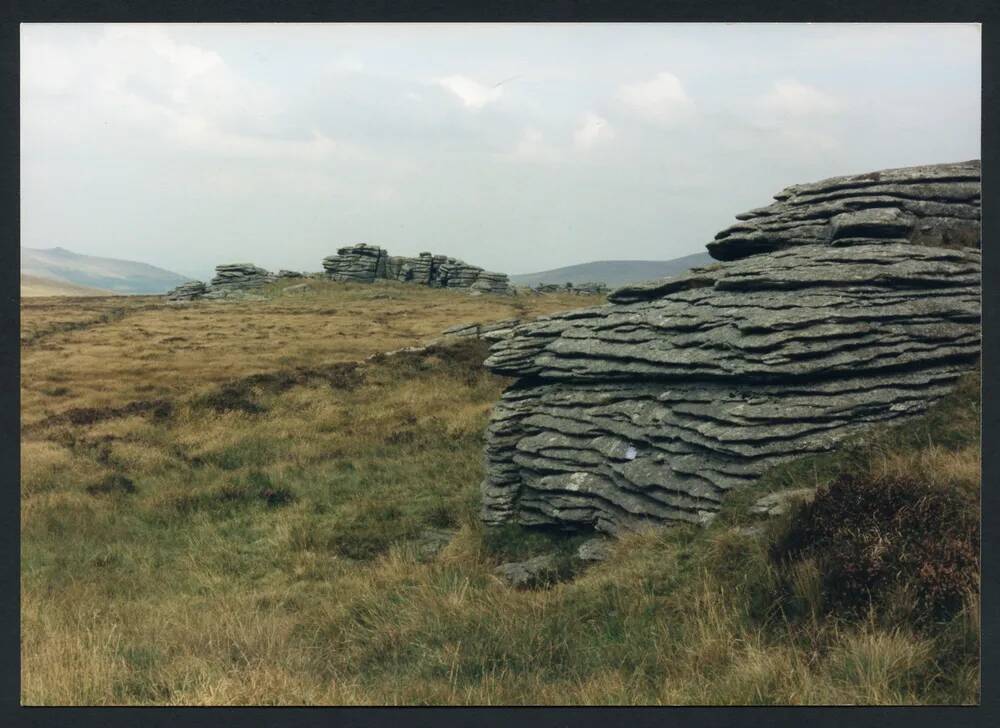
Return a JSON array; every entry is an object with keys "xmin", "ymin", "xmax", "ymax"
[{"xmin": 482, "ymin": 164, "xmax": 981, "ymax": 535}]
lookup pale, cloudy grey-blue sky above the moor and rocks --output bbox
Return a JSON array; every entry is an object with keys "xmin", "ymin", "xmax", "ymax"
[{"xmin": 21, "ymin": 23, "xmax": 980, "ymax": 280}]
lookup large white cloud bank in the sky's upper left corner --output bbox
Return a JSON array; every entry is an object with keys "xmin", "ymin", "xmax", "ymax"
[{"xmin": 22, "ymin": 25, "xmax": 332, "ymax": 160}]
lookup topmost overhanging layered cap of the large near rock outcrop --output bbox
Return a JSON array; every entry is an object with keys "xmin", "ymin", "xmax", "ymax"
[{"xmin": 708, "ymin": 160, "xmax": 980, "ymax": 260}]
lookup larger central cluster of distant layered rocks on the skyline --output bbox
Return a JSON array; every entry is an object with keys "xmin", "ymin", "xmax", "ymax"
[{"xmin": 323, "ymin": 243, "xmax": 513, "ymax": 294}]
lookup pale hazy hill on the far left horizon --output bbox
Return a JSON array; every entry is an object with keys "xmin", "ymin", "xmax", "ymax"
[{"xmin": 21, "ymin": 248, "xmax": 190, "ymax": 295}]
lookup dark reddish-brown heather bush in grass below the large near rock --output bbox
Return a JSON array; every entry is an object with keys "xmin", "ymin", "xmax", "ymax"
[{"xmin": 771, "ymin": 475, "xmax": 979, "ymax": 625}]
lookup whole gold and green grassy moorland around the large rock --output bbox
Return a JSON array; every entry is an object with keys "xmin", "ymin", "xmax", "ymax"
[{"xmin": 21, "ymin": 286, "xmax": 979, "ymax": 704}]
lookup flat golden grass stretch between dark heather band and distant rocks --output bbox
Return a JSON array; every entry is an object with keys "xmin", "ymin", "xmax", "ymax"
[{"xmin": 21, "ymin": 281, "xmax": 601, "ymax": 425}]
